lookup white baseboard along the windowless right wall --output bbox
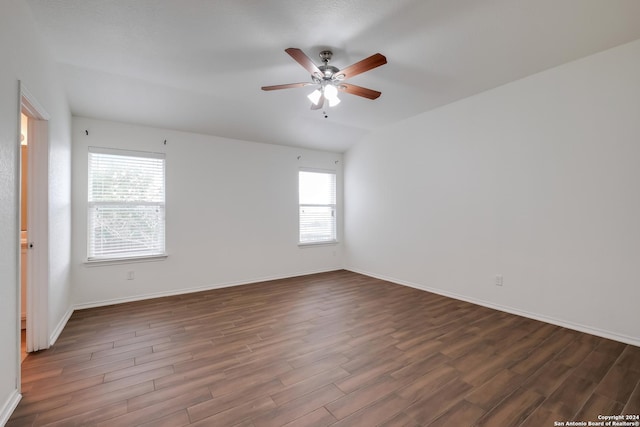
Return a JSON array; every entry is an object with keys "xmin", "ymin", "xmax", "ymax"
[{"xmin": 345, "ymin": 267, "xmax": 640, "ymax": 347}]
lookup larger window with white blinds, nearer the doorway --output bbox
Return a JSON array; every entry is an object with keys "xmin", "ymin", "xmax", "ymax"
[{"xmin": 87, "ymin": 147, "xmax": 165, "ymax": 261}]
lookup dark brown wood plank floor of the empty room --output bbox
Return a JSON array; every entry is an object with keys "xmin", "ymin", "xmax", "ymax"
[{"xmin": 8, "ymin": 271, "xmax": 640, "ymax": 427}]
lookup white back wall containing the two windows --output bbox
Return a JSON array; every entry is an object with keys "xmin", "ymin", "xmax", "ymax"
[{"xmin": 72, "ymin": 117, "xmax": 342, "ymax": 306}]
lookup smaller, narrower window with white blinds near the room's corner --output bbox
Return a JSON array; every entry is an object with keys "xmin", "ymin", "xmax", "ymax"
[{"xmin": 298, "ymin": 170, "xmax": 337, "ymax": 244}]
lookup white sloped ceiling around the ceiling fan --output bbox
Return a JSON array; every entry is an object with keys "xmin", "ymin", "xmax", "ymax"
[{"xmin": 27, "ymin": 0, "xmax": 640, "ymax": 152}]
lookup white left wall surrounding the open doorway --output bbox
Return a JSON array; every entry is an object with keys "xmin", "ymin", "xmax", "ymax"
[{"xmin": 0, "ymin": 0, "xmax": 71, "ymax": 424}]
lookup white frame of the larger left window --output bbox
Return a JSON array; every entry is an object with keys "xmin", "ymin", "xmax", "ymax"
[{"xmin": 86, "ymin": 146, "xmax": 167, "ymax": 264}]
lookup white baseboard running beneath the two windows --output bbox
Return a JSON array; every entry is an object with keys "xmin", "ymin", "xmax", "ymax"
[{"xmin": 73, "ymin": 267, "xmax": 343, "ymax": 310}]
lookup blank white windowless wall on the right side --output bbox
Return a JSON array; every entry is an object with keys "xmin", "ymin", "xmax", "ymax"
[{"xmin": 345, "ymin": 41, "xmax": 640, "ymax": 345}]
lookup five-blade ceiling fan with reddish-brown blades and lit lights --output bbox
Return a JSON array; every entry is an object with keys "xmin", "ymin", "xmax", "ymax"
[{"xmin": 262, "ymin": 47, "xmax": 387, "ymax": 110}]
